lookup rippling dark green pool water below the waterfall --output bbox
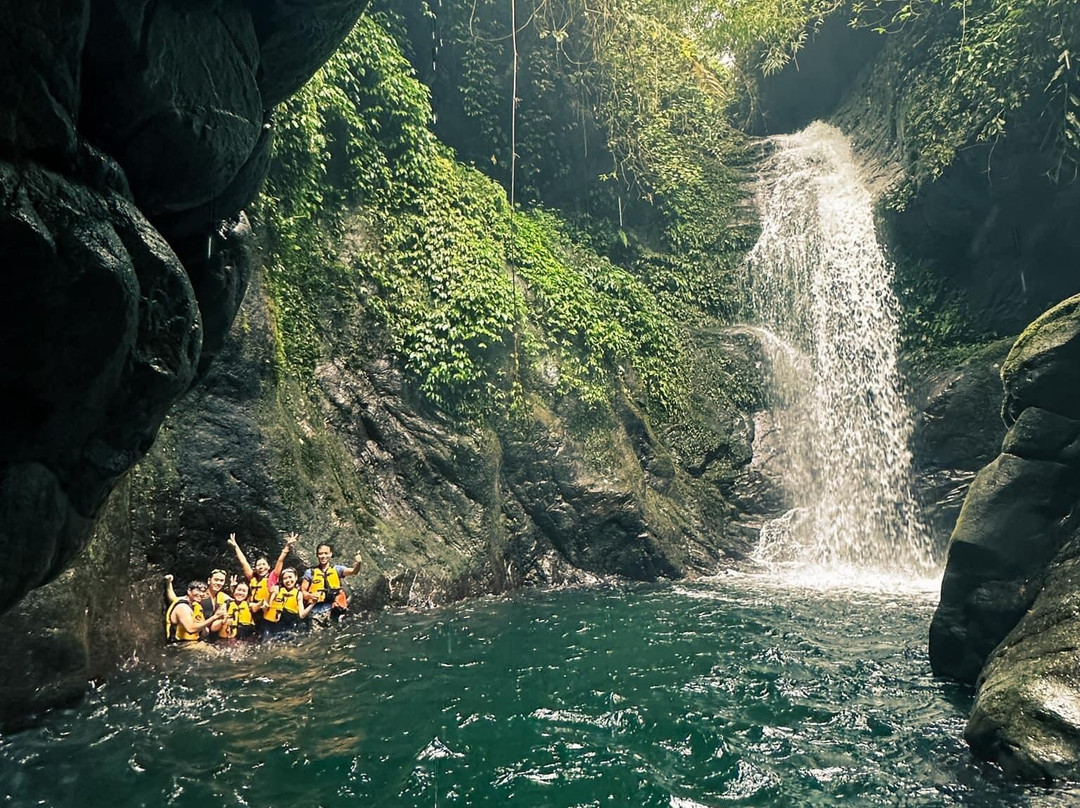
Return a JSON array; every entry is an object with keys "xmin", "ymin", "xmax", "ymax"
[{"xmin": 0, "ymin": 575, "xmax": 1080, "ymax": 808}]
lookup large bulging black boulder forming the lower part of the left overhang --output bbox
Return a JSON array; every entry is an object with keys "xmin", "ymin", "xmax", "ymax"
[{"xmin": 0, "ymin": 156, "xmax": 202, "ymax": 605}]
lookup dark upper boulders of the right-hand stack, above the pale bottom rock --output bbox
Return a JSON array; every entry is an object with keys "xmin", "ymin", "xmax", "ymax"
[{"xmin": 930, "ymin": 297, "xmax": 1080, "ymax": 704}]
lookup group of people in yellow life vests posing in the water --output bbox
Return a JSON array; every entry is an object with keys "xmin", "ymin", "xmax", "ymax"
[{"xmin": 165, "ymin": 533, "xmax": 361, "ymax": 643}]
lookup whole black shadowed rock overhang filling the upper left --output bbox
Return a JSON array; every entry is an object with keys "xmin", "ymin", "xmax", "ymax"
[{"xmin": 0, "ymin": 0, "xmax": 364, "ymax": 611}]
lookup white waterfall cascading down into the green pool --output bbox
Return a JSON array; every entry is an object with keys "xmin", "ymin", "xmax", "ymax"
[{"xmin": 747, "ymin": 123, "xmax": 931, "ymax": 574}]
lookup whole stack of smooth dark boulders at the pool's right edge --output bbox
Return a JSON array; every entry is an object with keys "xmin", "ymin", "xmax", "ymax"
[{"xmin": 930, "ymin": 297, "xmax": 1080, "ymax": 777}]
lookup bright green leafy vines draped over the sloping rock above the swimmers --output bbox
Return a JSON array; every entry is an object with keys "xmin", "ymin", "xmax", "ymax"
[{"xmin": 251, "ymin": 11, "xmax": 730, "ymax": 412}]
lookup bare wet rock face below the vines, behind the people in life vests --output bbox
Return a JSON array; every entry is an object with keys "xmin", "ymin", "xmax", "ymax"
[{"xmin": 0, "ymin": 230, "xmax": 757, "ymax": 726}]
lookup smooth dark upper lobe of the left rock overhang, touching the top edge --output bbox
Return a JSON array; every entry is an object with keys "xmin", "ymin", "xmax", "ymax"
[{"xmin": 79, "ymin": 0, "xmax": 264, "ymax": 221}]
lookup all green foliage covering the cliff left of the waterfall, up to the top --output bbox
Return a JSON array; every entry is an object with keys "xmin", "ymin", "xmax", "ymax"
[{"xmin": 259, "ymin": 0, "xmax": 842, "ymax": 423}]
